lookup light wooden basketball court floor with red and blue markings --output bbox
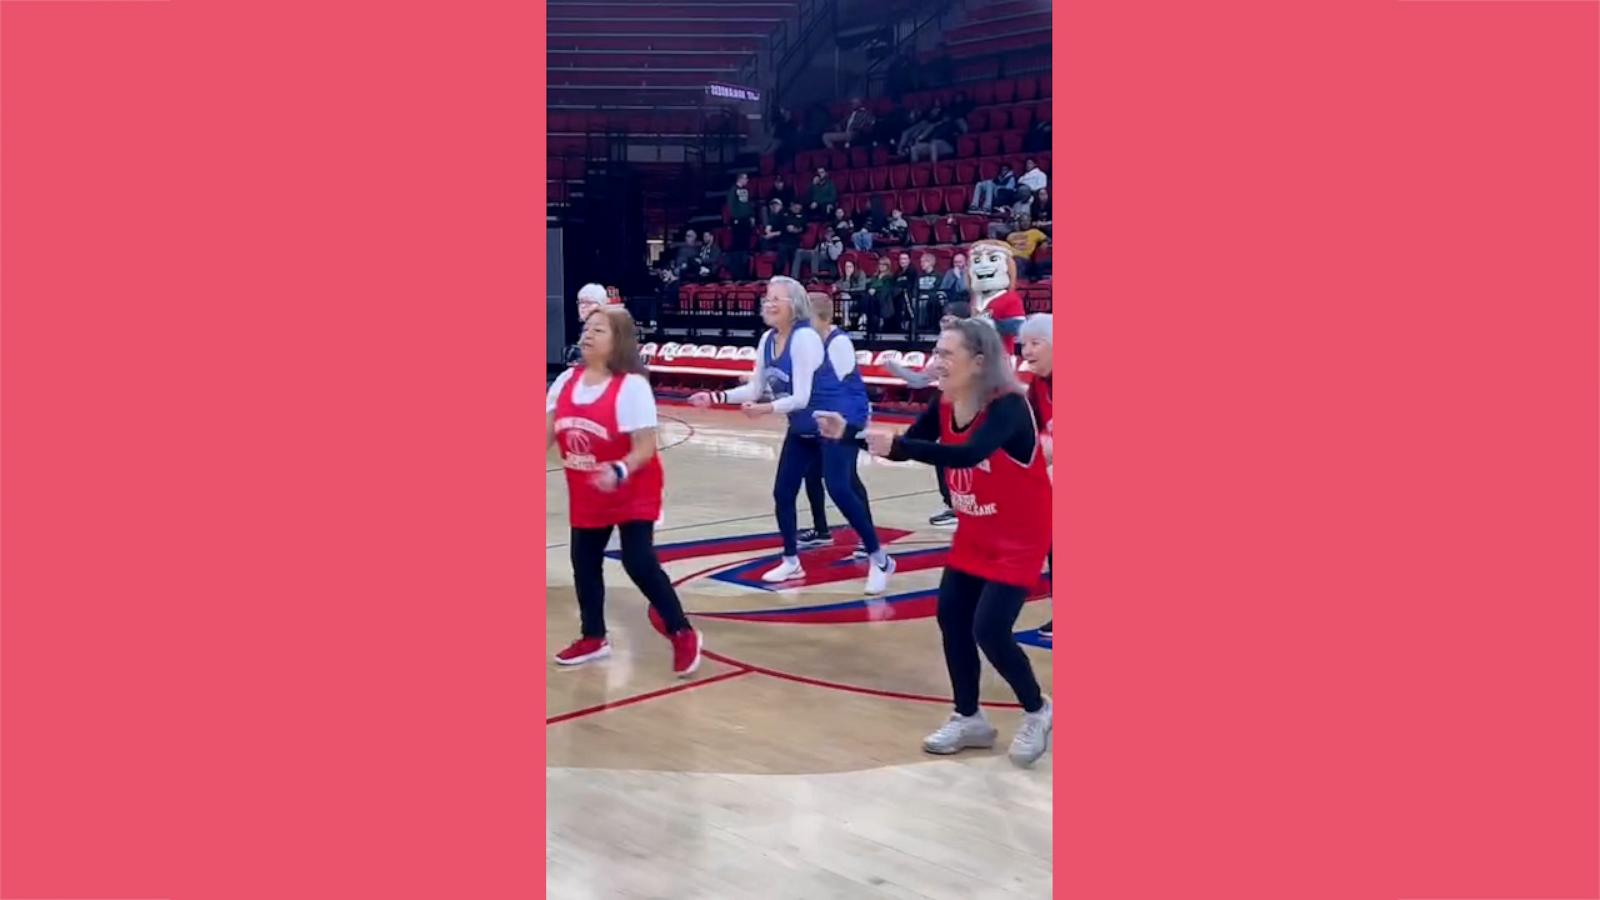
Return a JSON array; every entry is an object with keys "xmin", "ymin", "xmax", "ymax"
[{"xmin": 546, "ymin": 407, "xmax": 1066, "ymax": 900}]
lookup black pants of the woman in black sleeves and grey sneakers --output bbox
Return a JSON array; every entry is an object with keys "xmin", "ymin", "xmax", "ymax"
[{"xmin": 939, "ymin": 569, "xmax": 1045, "ymax": 716}]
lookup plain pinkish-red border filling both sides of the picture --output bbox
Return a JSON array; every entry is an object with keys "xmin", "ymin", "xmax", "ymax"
[{"xmin": 0, "ymin": 0, "xmax": 1600, "ymax": 900}]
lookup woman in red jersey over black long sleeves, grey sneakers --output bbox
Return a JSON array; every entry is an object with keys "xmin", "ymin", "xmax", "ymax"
[{"xmin": 824, "ymin": 319, "xmax": 1051, "ymax": 765}]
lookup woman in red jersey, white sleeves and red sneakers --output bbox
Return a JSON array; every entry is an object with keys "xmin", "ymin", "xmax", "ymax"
[{"xmin": 544, "ymin": 306, "xmax": 701, "ymax": 677}]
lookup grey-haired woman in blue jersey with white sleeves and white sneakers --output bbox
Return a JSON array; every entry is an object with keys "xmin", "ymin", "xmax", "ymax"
[{"xmin": 690, "ymin": 277, "xmax": 894, "ymax": 594}]
